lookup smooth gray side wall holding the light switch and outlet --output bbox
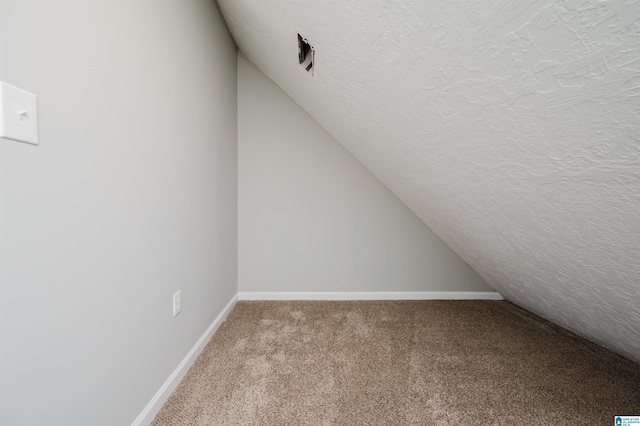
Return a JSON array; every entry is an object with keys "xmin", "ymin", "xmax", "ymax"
[{"xmin": 0, "ymin": 0, "xmax": 237, "ymax": 426}]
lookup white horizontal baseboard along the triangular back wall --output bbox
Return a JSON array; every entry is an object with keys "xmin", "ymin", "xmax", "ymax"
[{"xmin": 238, "ymin": 291, "xmax": 502, "ymax": 300}]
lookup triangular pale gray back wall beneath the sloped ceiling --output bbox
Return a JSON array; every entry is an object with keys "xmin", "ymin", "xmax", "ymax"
[{"xmin": 238, "ymin": 54, "xmax": 493, "ymax": 292}]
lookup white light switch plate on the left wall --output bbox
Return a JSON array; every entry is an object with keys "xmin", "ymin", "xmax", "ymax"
[{"xmin": 0, "ymin": 81, "xmax": 38, "ymax": 145}]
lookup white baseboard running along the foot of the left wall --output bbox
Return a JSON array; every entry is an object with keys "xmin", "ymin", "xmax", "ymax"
[{"xmin": 132, "ymin": 294, "xmax": 238, "ymax": 426}]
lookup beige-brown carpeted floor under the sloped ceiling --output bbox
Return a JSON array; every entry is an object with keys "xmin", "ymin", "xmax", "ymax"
[{"xmin": 153, "ymin": 301, "xmax": 640, "ymax": 426}]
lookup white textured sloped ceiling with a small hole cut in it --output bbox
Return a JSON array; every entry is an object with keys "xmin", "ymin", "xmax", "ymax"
[{"xmin": 219, "ymin": 0, "xmax": 640, "ymax": 361}]
